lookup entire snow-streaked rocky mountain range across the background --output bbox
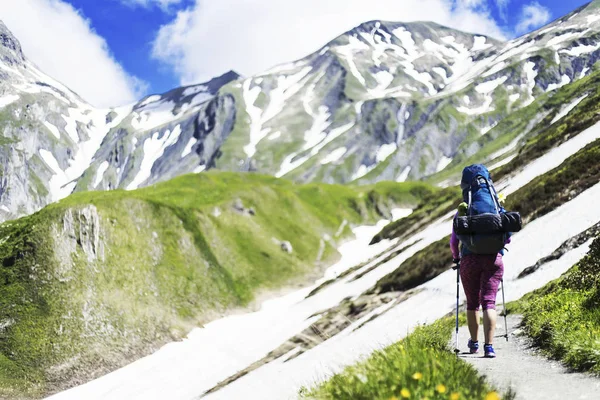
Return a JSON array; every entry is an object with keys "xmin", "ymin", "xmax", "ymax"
[{"xmin": 0, "ymin": 2, "xmax": 600, "ymax": 219}]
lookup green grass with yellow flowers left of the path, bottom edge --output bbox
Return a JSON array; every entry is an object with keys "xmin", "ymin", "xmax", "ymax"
[{"xmin": 301, "ymin": 318, "xmax": 510, "ymax": 400}]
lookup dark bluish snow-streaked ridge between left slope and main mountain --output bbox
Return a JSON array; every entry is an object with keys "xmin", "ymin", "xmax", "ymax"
[{"xmin": 76, "ymin": 72, "xmax": 239, "ymax": 191}]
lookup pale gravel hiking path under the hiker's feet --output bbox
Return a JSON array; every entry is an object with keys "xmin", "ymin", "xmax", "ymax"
[{"xmin": 453, "ymin": 316, "xmax": 600, "ymax": 400}]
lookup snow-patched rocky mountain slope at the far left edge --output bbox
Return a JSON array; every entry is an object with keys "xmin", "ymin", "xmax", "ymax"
[{"xmin": 0, "ymin": 23, "xmax": 126, "ymax": 219}]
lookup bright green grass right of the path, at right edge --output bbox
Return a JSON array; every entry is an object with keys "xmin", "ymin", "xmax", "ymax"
[{"xmin": 511, "ymin": 238, "xmax": 600, "ymax": 375}]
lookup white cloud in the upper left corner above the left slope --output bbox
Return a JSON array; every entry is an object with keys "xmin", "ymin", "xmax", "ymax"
[{"xmin": 0, "ymin": 0, "xmax": 145, "ymax": 107}]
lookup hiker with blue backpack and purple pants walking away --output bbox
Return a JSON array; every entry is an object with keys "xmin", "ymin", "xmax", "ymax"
[{"xmin": 450, "ymin": 164, "xmax": 510, "ymax": 358}]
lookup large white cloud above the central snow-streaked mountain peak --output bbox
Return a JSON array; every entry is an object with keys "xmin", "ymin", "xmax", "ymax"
[{"xmin": 153, "ymin": 0, "xmax": 505, "ymax": 84}]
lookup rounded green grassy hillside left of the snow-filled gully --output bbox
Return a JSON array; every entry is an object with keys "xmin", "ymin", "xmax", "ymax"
[{"xmin": 0, "ymin": 173, "xmax": 433, "ymax": 397}]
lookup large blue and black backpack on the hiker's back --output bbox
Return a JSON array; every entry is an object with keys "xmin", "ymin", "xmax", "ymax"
[{"xmin": 457, "ymin": 164, "xmax": 510, "ymax": 255}]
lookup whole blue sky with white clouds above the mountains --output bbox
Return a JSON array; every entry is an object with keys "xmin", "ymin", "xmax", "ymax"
[{"xmin": 0, "ymin": 0, "xmax": 588, "ymax": 106}]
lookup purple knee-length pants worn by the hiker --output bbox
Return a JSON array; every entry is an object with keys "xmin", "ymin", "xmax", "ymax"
[{"xmin": 460, "ymin": 254, "xmax": 504, "ymax": 311}]
